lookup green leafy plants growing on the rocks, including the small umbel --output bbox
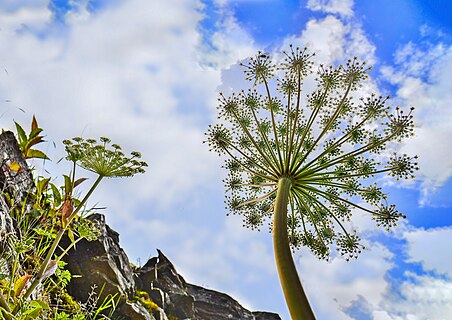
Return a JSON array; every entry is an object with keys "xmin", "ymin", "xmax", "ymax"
[{"xmin": 0, "ymin": 117, "xmax": 147, "ymax": 320}]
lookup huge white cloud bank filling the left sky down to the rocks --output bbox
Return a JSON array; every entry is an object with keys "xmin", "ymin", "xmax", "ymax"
[{"xmin": 0, "ymin": 0, "xmax": 274, "ymax": 314}]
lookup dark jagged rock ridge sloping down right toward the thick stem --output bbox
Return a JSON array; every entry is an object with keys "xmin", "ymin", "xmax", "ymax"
[{"xmin": 63, "ymin": 214, "xmax": 281, "ymax": 320}]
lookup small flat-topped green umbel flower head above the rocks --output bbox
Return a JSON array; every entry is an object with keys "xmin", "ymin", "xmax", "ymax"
[{"xmin": 63, "ymin": 137, "xmax": 147, "ymax": 178}]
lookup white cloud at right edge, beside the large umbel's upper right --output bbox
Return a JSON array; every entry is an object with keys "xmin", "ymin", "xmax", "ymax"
[{"xmin": 382, "ymin": 43, "xmax": 452, "ymax": 204}]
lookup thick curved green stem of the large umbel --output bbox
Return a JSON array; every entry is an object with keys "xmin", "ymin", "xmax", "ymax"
[{"xmin": 273, "ymin": 177, "xmax": 315, "ymax": 320}]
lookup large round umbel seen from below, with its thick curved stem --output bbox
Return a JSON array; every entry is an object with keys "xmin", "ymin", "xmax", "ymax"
[{"xmin": 205, "ymin": 46, "xmax": 417, "ymax": 319}]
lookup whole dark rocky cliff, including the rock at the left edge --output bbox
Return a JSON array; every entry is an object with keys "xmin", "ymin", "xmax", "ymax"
[{"xmin": 0, "ymin": 132, "xmax": 281, "ymax": 320}]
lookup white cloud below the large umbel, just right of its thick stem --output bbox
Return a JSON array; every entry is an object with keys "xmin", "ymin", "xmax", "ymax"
[{"xmin": 298, "ymin": 244, "xmax": 393, "ymax": 320}]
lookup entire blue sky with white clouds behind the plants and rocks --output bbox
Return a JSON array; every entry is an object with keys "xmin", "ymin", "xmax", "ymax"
[{"xmin": 0, "ymin": 0, "xmax": 452, "ymax": 320}]
